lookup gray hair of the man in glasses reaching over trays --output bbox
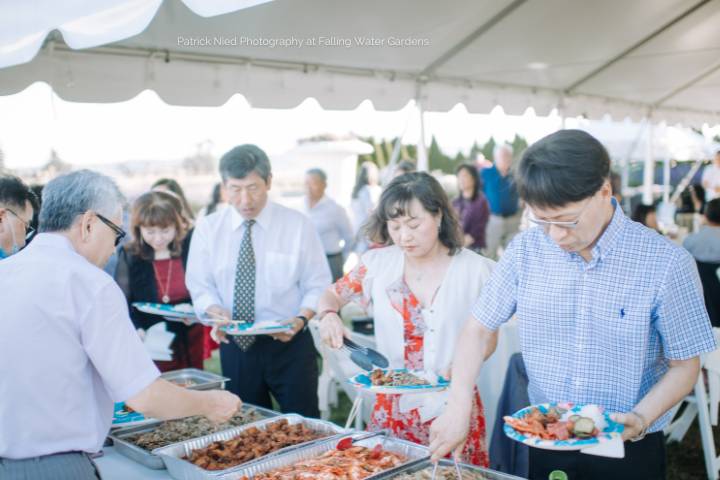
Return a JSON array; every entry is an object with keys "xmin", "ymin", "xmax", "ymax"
[{"xmin": 39, "ymin": 170, "xmax": 125, "ymax": 232}]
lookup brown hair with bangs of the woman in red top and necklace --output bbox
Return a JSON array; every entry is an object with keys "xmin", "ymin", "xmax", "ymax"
[{"xmin": 126, "ymin": 190, "xmax": 190, "ymax": 260}]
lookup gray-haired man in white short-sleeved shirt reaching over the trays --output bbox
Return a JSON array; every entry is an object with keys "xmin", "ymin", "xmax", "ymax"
[{"xmin": 0, "ymin": 170, "xmax": 240, "ymax": 480}]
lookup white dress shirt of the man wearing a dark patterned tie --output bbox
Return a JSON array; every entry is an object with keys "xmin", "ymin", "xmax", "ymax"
[{"xmin": 185, "ymin": 201, "xmax": 331, "ymax": 322}]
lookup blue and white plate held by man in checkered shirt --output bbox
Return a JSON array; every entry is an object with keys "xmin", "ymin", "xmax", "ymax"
[{"xmin": 503, "ymin": 402, "xmax": 625, "ymax": 450}]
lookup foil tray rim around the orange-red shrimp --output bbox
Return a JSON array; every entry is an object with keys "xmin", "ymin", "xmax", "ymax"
[{"xmin": 220, "ymin": 435, "xmax": 430, "ymax": 480}]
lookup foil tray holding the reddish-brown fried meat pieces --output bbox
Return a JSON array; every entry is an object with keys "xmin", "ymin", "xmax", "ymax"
[{"xmin": 153, "ymin": 413, "xmax": 348, "ymax": 480}]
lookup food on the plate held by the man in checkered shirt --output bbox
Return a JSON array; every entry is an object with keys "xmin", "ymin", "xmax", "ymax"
[{"xmin": 503, "ymin": 406, "xmax": 604, "ymax": 440}]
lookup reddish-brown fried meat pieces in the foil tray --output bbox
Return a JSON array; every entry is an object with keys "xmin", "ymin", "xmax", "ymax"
[{"xmin": 186, "ymin": 419, "xmax": 327, "ymax": 470}]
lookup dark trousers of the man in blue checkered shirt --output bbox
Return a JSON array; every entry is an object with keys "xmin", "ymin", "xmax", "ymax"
[{"xmin": 530, "ymin": 432, "xmax": 666, "ymax": 480}]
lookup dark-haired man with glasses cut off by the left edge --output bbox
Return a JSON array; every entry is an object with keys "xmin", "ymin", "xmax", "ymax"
[{"xmin": 0, "ymin": 175, "xmax": 37, "ymax": 260}]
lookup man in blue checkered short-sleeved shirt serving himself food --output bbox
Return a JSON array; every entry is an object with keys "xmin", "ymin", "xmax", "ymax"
[{"xmin": 430, "ymin": 130, "xmax": 715, "ymax": 480}]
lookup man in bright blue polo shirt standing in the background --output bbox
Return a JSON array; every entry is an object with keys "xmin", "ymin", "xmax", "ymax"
[{"xmin": 480, "ymin": 144, "xmax": 521, "ymax": 258}]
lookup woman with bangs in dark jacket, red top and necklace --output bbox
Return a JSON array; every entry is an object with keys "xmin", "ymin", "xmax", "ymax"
[{"xmin": 115, "ymin": 191, "xmax": 203, "ymax": 372}]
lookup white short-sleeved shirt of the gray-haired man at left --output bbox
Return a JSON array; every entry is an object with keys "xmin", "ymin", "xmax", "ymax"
[{"xmin": 0, "ymin": 233, "xmax": 160, "ymax": 459}]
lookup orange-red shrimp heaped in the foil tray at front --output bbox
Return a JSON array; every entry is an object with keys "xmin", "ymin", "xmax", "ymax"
[{"xmin": 242, "ymin": 445, "xmax": 407, "ymax": 480}]
